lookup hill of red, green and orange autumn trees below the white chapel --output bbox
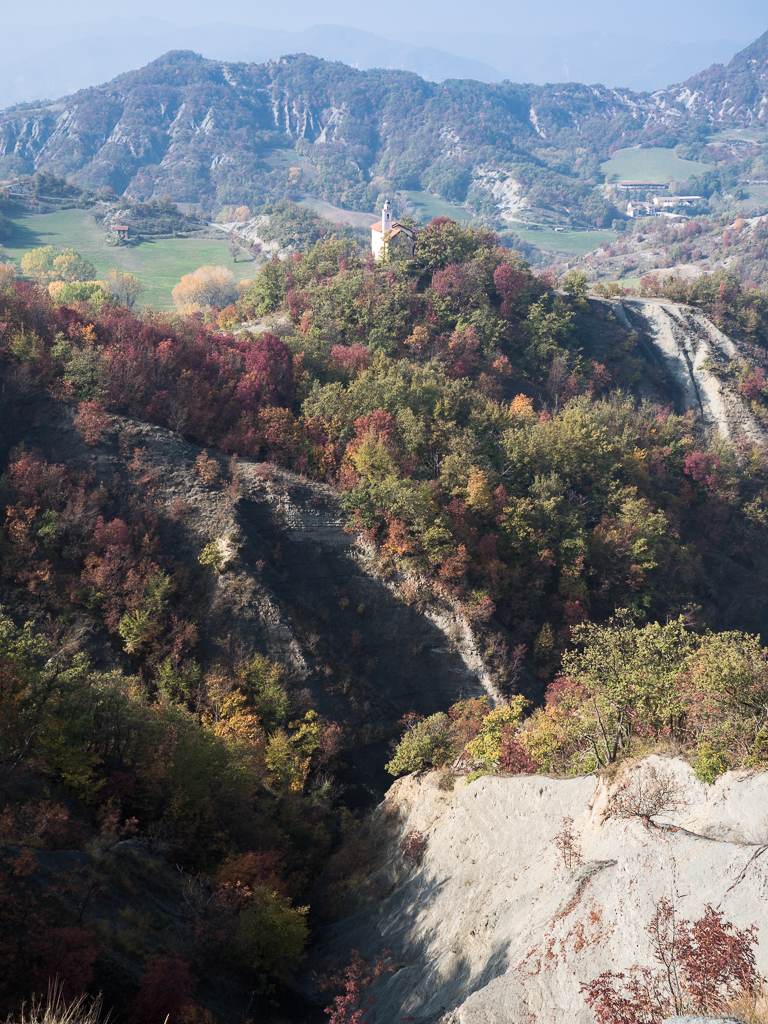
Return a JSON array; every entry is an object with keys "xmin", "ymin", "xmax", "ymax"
[{"xmin": 6, "ymin": 220, "xmax": 765, "ymax": 671}]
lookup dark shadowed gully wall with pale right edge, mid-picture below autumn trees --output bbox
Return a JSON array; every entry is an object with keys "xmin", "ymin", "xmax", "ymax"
[{"xmin": 236, "ymin": 461, "xmax": 498, "ymax": 793}]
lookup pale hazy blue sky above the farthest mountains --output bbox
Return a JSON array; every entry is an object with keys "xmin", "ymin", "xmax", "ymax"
[{"xmin": 0, "ymin": 0, "xmax": 768, "ymax": 40}]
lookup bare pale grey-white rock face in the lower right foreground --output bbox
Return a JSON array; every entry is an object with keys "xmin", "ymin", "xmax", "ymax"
[{"xmin": 318, "ymin": 756, "xmax": 768, "ymax": 1024}]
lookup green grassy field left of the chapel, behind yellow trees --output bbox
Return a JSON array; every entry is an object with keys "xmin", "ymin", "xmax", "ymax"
[{"xmin": 4, "ymin": 210, "xmax": 256, "ymax": 309}]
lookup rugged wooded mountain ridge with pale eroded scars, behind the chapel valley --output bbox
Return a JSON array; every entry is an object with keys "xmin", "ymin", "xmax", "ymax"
[{"xmin": 0, "ymin": 33, "xmax": 768, "ymax": 224}]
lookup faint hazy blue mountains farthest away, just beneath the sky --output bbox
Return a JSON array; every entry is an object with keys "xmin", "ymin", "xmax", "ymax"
[{"xmin": 0, "ymin": 17, "xmax": 749, "ymax": 108}]
